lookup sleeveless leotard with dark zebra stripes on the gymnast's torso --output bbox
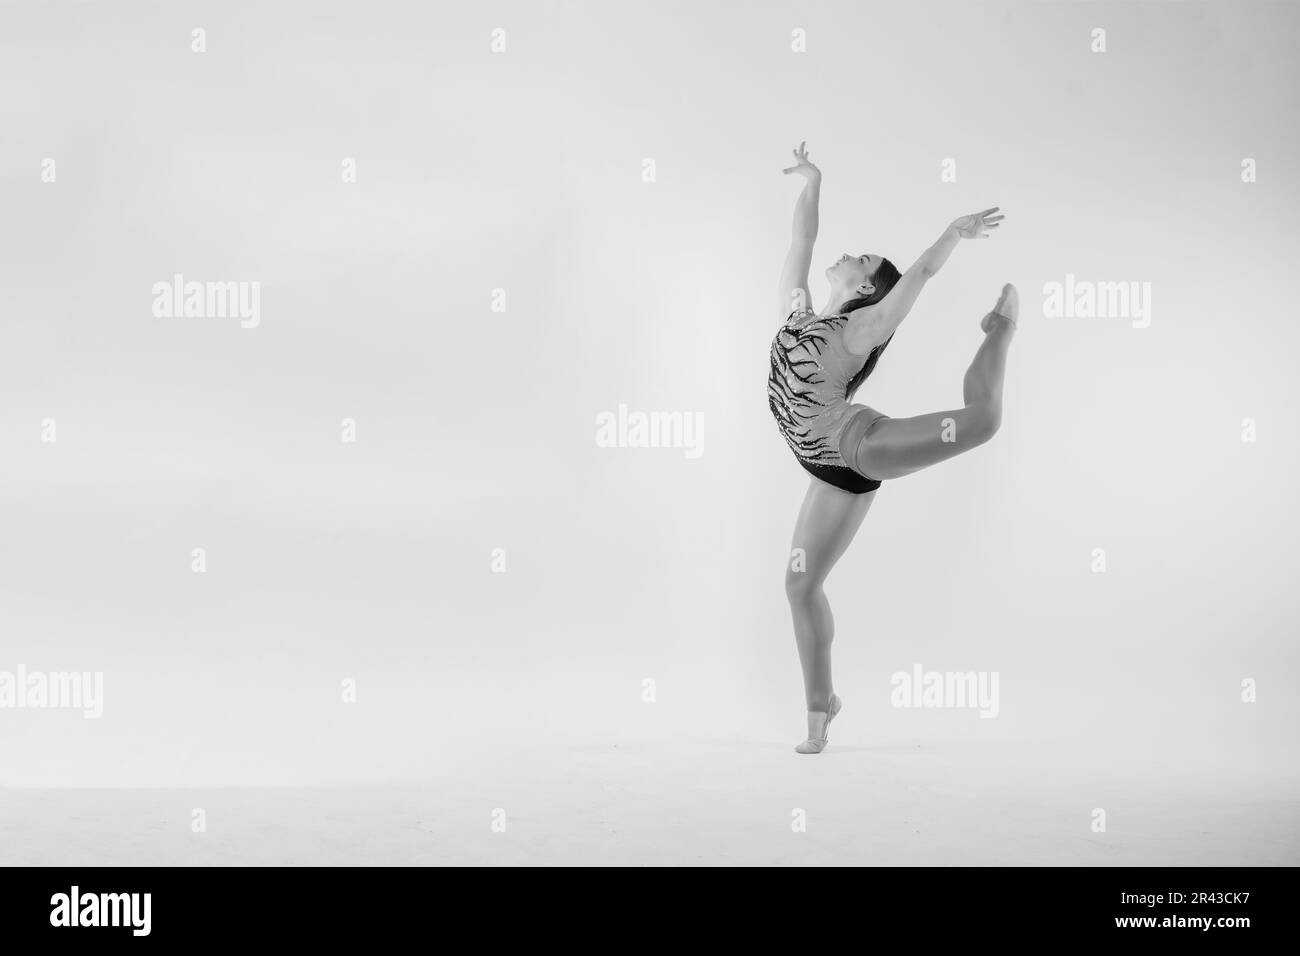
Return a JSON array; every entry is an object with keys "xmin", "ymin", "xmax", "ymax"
[{"xmin": 767, "ymin": 310, "xmax": 893, "ymax": 494}]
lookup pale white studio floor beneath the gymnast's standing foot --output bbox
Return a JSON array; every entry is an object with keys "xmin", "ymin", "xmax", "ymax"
[{"xmin": 0, "ymin": 735, "xmax": 1300, "ymax": 866}]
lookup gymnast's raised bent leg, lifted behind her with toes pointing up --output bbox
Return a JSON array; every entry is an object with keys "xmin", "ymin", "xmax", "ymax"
[{"xmin": 854, "ymin": 285, "xmax": 1019, "ymax": 481}]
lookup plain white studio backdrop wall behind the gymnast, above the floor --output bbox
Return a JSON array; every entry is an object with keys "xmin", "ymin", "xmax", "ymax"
[{"xmin": 0, "ymin": 1, "xmax": 1300, "ymax": 853}]
